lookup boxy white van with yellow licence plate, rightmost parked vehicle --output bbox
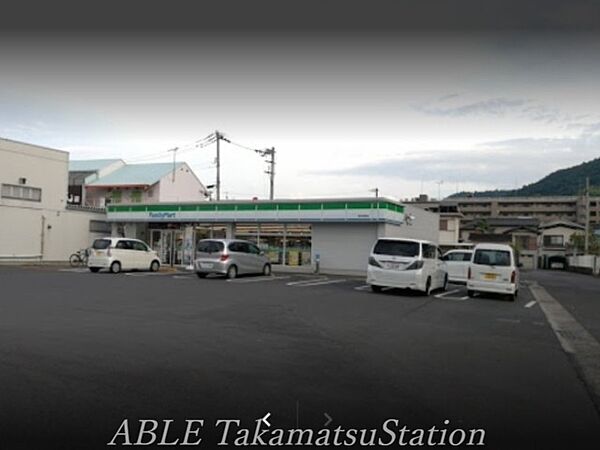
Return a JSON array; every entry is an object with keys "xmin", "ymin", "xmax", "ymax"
[{"xmin": 467, "ymin": 244, "xmax": 519, "ymax": 301}]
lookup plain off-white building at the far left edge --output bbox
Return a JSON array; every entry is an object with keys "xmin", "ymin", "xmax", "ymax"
[{"xmin": 0, "ymin": 139, "xmax": 110, "ymax": 261}]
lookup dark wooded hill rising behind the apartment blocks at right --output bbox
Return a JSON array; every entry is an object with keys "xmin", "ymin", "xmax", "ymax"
[{"xmin": 449, "ymin": 158, "xmax": 600, "ymax": 198}]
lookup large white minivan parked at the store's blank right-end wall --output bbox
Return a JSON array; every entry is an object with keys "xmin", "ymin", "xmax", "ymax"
[{"xmin": 367, "ymin": 238, "xmax": 448, "ymax": 295}]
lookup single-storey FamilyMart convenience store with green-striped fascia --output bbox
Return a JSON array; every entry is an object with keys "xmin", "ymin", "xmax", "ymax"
[{"xmin": 107, "ymin": 198, "xmax": 438, "ymax": 274}]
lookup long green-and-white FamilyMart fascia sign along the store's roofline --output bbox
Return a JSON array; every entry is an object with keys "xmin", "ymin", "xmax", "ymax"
[{"xmin": 107, "ymin": 200, "xmax": 404, "ymax": 223}]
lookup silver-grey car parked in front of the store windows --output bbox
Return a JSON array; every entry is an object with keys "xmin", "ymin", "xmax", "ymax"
[{"xmin": 194, "ymin": 239, "xmax": 271, "ymax": 278}]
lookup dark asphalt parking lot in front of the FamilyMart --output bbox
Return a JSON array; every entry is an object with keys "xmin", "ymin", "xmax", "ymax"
[{"xmin": 0, "ymin": 268, "xmax": 600, "ymax": 449}]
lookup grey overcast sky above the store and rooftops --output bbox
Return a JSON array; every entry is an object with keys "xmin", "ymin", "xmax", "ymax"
[{"xmin": 0, "ymin": 30, "xmax": 600, "ymax": 199}]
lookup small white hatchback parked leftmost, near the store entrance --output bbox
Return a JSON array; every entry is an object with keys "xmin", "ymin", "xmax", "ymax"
[{"xmin": 88, "ymin": 237, "xmax": 160, "ymax": 273}]
